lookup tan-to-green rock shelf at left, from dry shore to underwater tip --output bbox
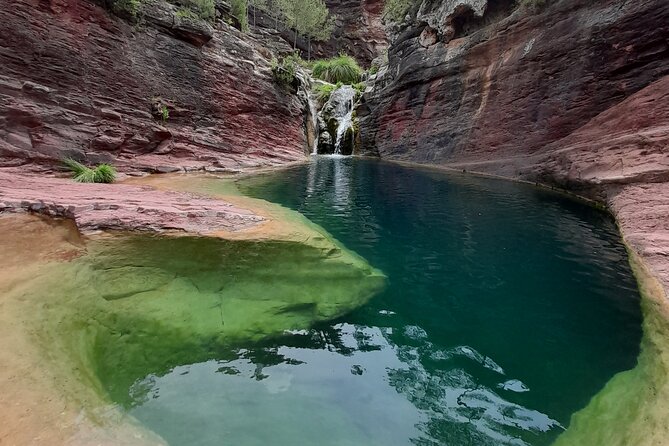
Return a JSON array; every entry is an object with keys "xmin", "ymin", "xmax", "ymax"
[{"xmin": 0, "ymin": 201, "xmax": 385, "ymax": 444}]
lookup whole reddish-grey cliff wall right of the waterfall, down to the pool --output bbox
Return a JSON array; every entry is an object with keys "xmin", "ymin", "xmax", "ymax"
[{"xmin": 358, "ymin": 0, "xmax": 669, "ymax": 289}]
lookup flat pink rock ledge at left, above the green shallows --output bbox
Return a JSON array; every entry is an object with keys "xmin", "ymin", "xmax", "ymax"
[{"xmin": 0, "ymin": 169, "xmax": 264, "ymax": 234}]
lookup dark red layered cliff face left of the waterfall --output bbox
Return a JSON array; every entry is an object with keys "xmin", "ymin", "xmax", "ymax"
[{"xmin": 0, "ymin": 0, "xmax": 307, "ymax": 171}]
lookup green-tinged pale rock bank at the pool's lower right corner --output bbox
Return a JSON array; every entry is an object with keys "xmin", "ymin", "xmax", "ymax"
[{"xmin": 555, "ymin": 249, "xmax": 669, "ymax": 446}]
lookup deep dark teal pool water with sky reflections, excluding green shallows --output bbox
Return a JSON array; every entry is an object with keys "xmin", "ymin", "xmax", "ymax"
[{"xmin": 129, "ymin": 157, "xmax": 641, "ymax": 446}]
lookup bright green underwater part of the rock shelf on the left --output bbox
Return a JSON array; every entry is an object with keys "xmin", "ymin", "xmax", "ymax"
[{"xmin": 26, "ymin": 230, "xmax": 385, "ymax": 403}]
